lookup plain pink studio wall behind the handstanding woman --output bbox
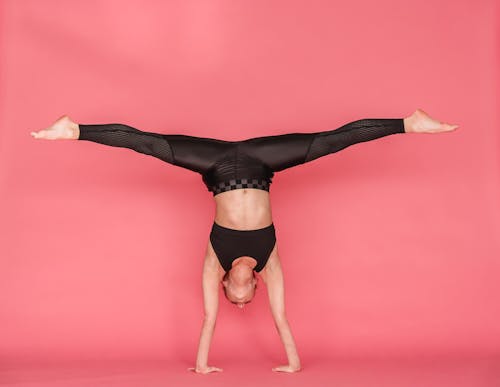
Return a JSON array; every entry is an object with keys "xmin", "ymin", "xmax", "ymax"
[{"xmin": 0, "ymin": 0, "xmax": 500, "ymax": 386}]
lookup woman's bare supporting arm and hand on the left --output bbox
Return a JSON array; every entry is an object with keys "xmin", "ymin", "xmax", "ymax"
[{"xmin": 190, "ymin": 254, "xmax": 222, "ymax": 374}]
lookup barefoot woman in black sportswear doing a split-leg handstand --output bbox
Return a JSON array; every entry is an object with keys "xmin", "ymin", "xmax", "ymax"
[{"xmin": 31, "ymin": 109, "xmax": 458, "ymax": 373}]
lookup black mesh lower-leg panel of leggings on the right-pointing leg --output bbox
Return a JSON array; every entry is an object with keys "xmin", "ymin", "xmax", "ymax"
[{"xmin": 304, "ymin": 118, "xmax": 404, "ymax": 162}]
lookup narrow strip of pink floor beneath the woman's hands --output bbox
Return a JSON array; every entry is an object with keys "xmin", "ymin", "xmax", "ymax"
[{"xmin": 0, "ymin": 357, "xmax": 500, "ymax": 387}]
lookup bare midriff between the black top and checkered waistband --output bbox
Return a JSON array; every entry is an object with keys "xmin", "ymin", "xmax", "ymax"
[{"xmin": 214, "ymin": 188, "xmax": 272, "ymax": 230}]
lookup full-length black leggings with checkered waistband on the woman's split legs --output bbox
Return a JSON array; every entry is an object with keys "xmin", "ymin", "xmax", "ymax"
[{"xmin": 79, "ymin": 118, "xmax": 405, "ymax": 196}]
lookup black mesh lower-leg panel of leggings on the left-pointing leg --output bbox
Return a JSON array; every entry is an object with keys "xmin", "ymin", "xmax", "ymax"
[{"xmin": 78, "ymin": 124, "xmax": 174, "ymax": 164}]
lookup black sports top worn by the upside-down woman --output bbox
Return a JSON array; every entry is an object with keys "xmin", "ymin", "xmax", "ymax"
[{"xmin": 210, "ymin": 222, "xmax": 276, "ymax": 272}]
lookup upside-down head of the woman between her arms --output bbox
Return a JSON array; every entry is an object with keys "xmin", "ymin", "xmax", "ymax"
[{"xmin": 222, "ymin": 268, "xmax": 257, "ymax": 308}]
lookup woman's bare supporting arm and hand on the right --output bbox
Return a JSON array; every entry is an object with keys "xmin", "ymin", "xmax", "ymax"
[{"xmin": 262, "ymin": 254, "xmax": 301, "ymax": 372}]
